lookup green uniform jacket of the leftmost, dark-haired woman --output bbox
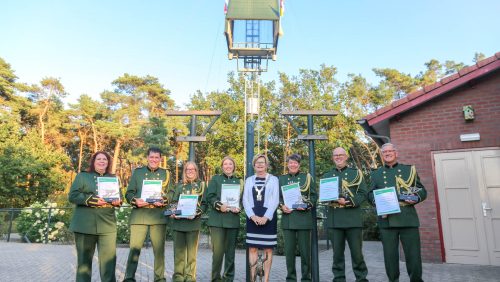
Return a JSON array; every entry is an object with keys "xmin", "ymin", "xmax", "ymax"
[{"xmin": 68, "ymin": 172, "xmax": 116, "ymax": 235}]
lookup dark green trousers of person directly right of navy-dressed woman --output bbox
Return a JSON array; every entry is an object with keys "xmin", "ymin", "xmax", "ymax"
[{"xmin": 283, "ymin": 229, "xmax": 311, "ymax": 282}]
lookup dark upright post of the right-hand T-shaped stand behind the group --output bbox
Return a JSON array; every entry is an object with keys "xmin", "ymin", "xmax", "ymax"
[{"xmin": 307, "ymin": 115, "xmax": 319, "ymax": 281}]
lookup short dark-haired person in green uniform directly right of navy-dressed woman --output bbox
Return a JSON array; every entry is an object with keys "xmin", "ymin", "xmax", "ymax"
[{"xmin": 279, "ymin": 154, "xmax": 317, "ymax": 281}]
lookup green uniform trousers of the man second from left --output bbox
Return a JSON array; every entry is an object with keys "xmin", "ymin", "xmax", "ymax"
[{"xmin": 123, "ymin": 224, "xmax": 167, "ymax": 282}]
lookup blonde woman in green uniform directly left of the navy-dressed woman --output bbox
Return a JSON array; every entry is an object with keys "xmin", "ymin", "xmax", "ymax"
[{"xmin": 206, "ymin": 157, "xmax": 243, "ymax": 282}]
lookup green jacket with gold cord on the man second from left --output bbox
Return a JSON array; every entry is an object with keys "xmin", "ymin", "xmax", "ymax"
[{"xmin": 125, "ymin": 166, "xmax": 170, "ymax": 225}]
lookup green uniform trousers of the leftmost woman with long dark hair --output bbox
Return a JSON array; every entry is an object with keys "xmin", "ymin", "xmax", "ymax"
[{"xmin": 75, "ymin": 232, "xmax": 116, "ymax": 282}]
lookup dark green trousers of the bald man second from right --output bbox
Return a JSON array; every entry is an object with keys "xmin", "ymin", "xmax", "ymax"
[{"xmin": 331, "ymin": 227, "xmax": 368, "ymax": 282}]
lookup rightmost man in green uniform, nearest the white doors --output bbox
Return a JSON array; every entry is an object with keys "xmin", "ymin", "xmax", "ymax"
[{"xmin": 368, "ymin": 143, "xmax": 427, "ymax": 282}]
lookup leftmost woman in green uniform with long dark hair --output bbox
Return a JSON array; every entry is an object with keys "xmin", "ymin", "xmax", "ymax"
[{"xmin": 68, "ymin": 151, "xmax": 121, "ymax": 282}]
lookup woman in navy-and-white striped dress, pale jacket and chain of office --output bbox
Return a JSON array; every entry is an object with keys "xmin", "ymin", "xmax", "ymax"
[{"xmin": 243, "ymin": 154, "xmax": 279, "ymax": 282}]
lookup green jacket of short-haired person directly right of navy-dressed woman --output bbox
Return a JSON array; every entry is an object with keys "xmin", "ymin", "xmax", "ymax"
[{"xmin": 279, "ymin": 172, "xmax": 318, "ymax": 229}]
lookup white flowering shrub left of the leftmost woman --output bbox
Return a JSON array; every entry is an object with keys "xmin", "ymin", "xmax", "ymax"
[{"xmin": 16, "ymin": 201, "xmax": 71, "ymax": 243}]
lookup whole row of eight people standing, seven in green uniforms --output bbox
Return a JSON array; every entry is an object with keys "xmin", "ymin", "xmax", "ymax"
[{"xmin": 69, "ymin": 143, "xmax": 426, "ymax": 281}]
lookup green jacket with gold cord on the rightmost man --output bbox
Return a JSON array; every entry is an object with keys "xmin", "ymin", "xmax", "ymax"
[{"xmin": 368, "ymin": 163, "xmax": 427, "ymax": 228}]
